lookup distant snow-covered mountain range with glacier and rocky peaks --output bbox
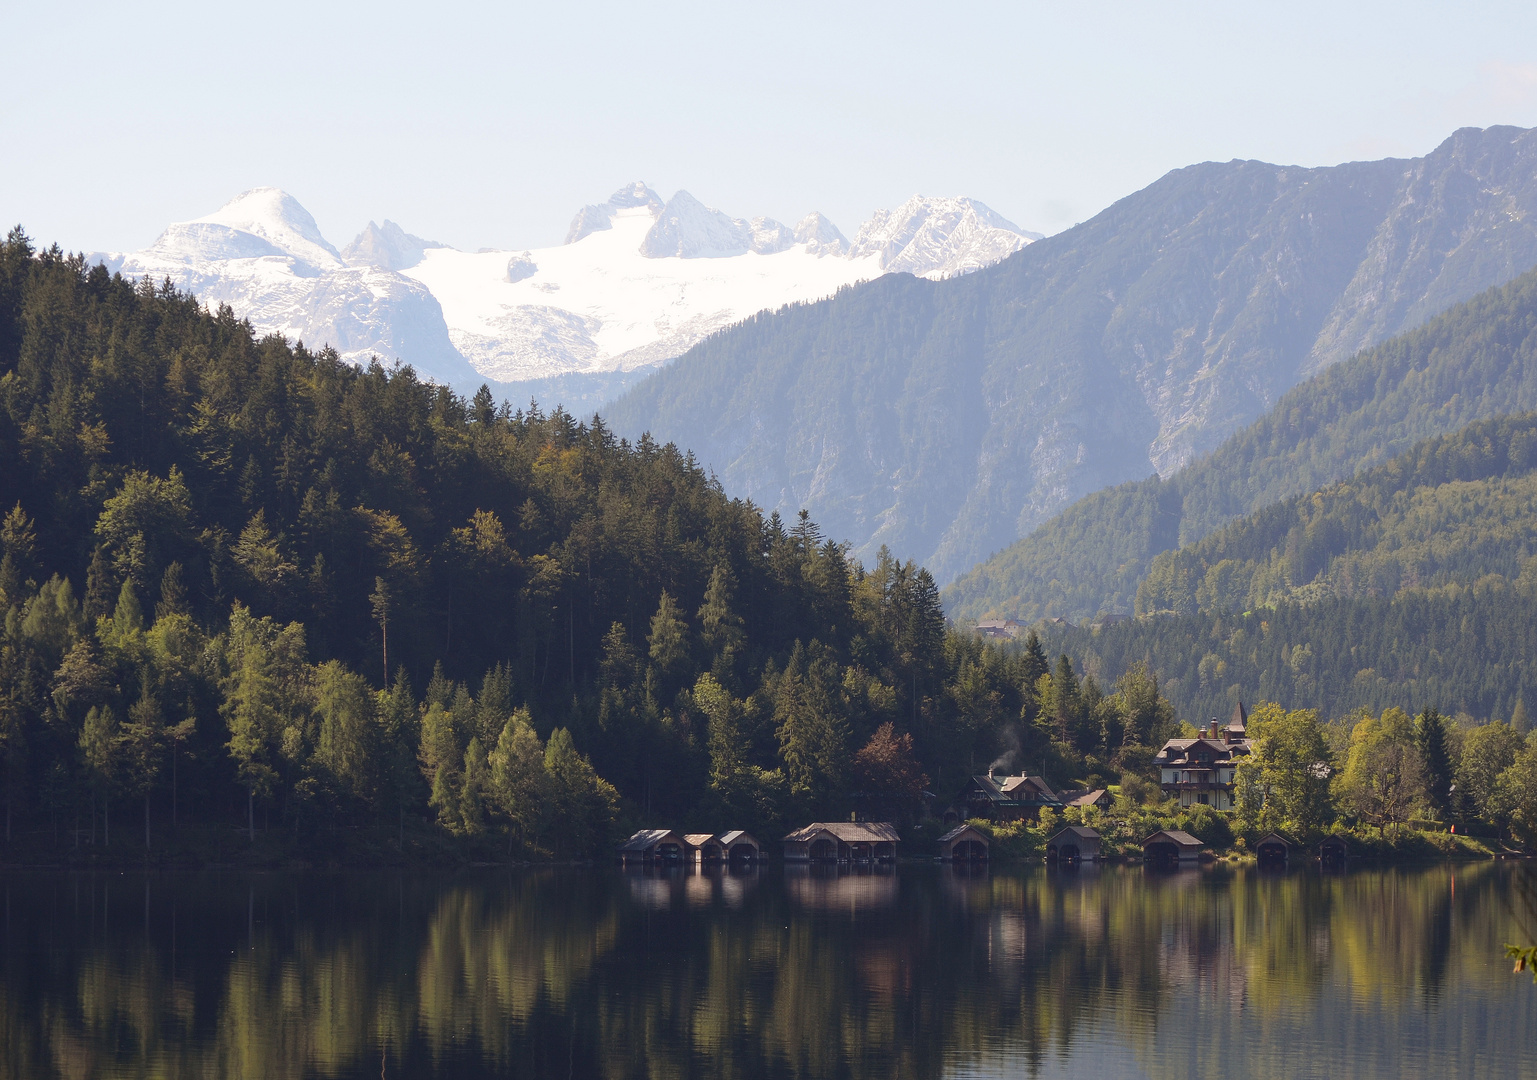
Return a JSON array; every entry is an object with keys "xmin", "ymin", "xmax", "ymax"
[{"xmin": 89, "ymin": 183, "xmax": 1039, "ymax": 407}]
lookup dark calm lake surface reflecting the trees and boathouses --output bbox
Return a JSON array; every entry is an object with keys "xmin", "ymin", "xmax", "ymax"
[{"xmin": 0, "ymin": 863, "xmax": 1537, "ymax": 1080}]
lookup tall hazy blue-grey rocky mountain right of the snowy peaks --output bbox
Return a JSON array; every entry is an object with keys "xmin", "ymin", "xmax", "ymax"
[{"xmin": 607, "ymin": 128, "xmax": 1537, "ymax": 583}]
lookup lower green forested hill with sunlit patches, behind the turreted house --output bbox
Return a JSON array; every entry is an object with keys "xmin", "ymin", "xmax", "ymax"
[{"xmin": 1008, "ymin": 413, "xmax": 1537, "ymax": 740}]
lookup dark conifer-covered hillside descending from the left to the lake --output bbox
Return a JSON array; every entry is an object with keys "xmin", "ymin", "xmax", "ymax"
[{"xmin": 0, "ymin": 230, "xmax": 1171, "ymax": 857}]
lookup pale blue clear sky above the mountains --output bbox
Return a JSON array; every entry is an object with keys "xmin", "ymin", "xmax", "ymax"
[{"xmin": 9, "ymin": 0, "xmax": 1537, "ymax": 249}]
